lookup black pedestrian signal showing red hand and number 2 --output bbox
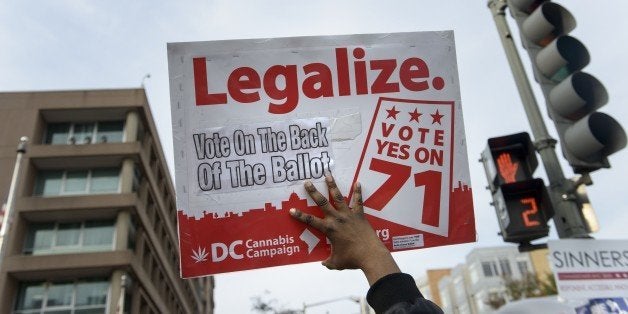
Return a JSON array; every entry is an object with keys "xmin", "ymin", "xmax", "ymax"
[{"xmin": 481, "ymin": 132, "xmax": 554, "ymax": 246}]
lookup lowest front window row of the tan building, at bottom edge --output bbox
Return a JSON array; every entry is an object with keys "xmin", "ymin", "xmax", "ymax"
[{"xmin": 15, "ymin": 280, "xmax": 109, "ymax": 314}]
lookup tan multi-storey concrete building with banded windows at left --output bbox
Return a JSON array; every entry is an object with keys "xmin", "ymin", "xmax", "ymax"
[{"xmin": 0, "ymin": 89, "xmax": 214, "ymax": 314}]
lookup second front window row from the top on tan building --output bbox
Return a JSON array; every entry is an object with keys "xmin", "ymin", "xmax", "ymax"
[{"xmin": 34, "ymin": 168, "xmax": 120, "ymax": 196}]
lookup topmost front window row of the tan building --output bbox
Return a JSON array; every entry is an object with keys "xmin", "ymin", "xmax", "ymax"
[{"xmin": 44, "ymin": 121, "xmax": 124, "ymax": 144}]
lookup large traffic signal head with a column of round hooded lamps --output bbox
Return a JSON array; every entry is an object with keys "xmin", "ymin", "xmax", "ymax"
[{"xmin": 508, "ymin": 0, "xmax": 626, "ymax": 173}]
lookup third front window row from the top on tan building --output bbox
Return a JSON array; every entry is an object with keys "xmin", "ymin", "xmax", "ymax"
[{"xmin": 24, "ymin": 221, "xmax": 115, "ymax": 255}]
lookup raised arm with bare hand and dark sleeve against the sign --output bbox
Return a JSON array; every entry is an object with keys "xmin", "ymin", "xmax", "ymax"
[{"xmin": 290, "ymin": 175, "xmax": 443, "ymax": 314}]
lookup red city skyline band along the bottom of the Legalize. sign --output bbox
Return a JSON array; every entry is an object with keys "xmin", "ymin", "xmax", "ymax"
[{"xmin": 178, "ymin": 182, "xmax": 475, "ymax": 277}]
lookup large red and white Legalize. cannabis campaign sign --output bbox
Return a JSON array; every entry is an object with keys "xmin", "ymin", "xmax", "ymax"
[{"xmin": 168, "ymin": 31, "xmax": 475, "ymax": 277}]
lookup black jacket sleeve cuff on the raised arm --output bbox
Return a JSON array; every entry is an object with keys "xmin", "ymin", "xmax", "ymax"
[{"xmin": 366, "ymin": 273, "xmax": 443, "ymax": 314}]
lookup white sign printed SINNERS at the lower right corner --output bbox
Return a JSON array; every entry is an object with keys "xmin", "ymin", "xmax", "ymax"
[{"xmin": 548, "ymin": 239, "xmax": 628, "ymax": 299}]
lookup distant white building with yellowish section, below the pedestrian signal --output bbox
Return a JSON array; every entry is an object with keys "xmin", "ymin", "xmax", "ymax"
[{"xmin": 431, "ymin": 246, "xmax": 551, "ymax": 314}]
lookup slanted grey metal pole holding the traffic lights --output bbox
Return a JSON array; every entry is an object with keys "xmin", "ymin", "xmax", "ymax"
[{"xmin": 488, "ymin": 0, "xmax": 589, "ymax": 239}]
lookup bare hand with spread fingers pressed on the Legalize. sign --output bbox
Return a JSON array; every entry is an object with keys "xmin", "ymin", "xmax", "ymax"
[{"xmin": 290, "ymin": 175, "xmax": 400, "ymax": 285}]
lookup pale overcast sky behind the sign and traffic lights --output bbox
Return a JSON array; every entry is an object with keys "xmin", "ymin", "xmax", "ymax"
[{"xmin": 0, "ymin": 0, "xmax": 628, "ymax": 314}]
